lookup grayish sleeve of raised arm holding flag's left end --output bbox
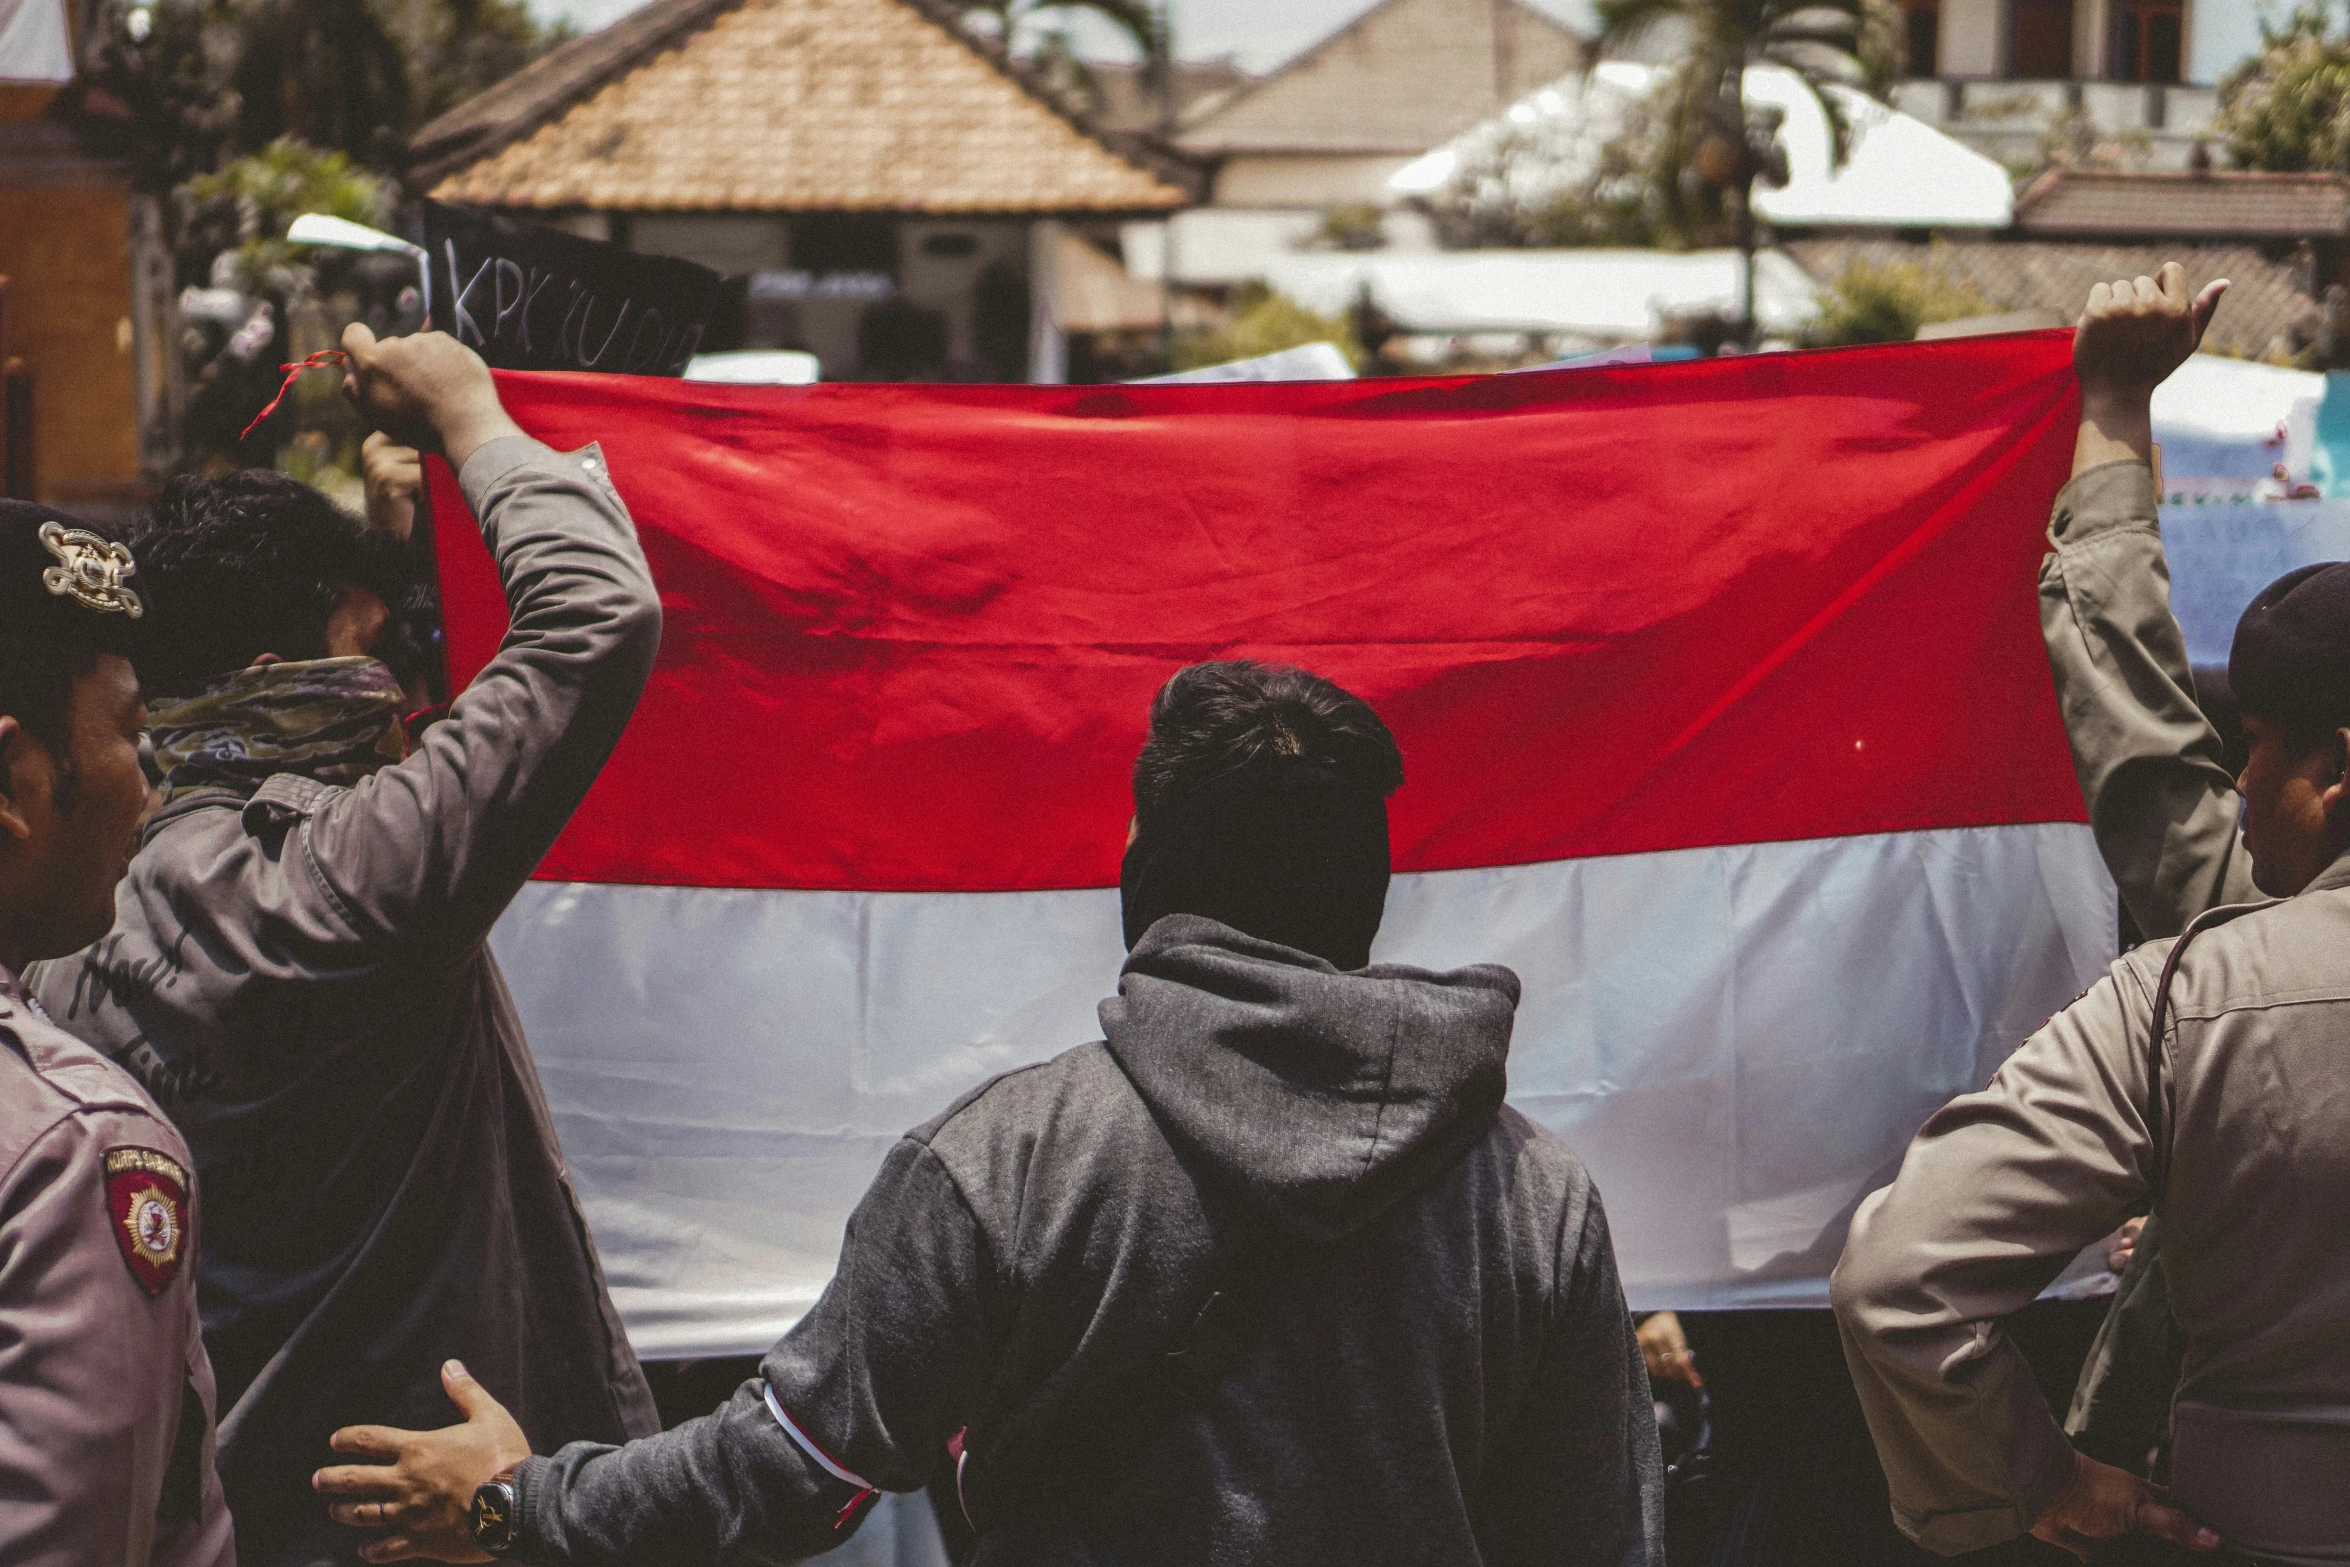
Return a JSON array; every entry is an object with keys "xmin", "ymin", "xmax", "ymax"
[{"xmin": 298, "ymin": 437, "xmax": 660, "ymax": 951}]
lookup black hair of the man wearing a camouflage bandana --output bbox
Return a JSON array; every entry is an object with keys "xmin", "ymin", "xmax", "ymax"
[{"xmin": 129, "ymin": 468, "xmax": 409, "ymax": 695}]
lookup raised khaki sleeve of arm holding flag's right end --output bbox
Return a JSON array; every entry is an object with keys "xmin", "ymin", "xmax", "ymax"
[{"xmin": 2040, "ymin": 463, "xmax": 2261, "ymax": 937}]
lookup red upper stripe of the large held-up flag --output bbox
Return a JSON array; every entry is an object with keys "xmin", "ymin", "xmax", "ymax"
[{"xmin": 435, "ymin": 331, "xmax": 2082, "ymax": 890}]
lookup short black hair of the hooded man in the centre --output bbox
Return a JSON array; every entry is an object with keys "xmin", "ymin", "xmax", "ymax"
[{"xmin": 1135, "ymin": 658, "xmax": 1403, "ymax": 825}]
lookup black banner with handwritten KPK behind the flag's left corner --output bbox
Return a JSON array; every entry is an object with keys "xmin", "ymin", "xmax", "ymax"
[{"xmin": 425, "ymin": 202, "xmax": 719, "ymax": 376}]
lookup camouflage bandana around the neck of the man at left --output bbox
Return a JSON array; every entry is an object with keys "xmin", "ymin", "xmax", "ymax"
[{"xmin": 148, "ymin": 658, "xmax": 409, "ymax": 801}]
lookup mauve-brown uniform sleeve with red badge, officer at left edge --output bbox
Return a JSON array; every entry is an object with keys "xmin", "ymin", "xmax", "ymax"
[{"xmin": 0, "ymin": 1109, "xmax": 235, "ymax": 1567}]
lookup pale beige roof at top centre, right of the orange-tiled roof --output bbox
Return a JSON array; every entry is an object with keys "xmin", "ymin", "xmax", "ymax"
[{"xmin": 1180, "ymin": 0, "xmax": 1584, "ymax": 153}]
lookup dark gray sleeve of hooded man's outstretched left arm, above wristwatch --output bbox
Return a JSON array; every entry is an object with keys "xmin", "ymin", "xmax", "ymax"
[{"xmin": 512, "ymin": 1139, "xmax": 996, "ymax": 1567}]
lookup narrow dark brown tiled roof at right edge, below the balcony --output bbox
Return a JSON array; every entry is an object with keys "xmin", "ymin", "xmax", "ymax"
[{"xmin": 2016, "ymin": 169, "xmax": 2350, "ymax": 240}]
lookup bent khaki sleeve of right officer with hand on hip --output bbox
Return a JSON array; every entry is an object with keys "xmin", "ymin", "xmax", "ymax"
[{"xmin": 1828, "ymin": 963, "xmax": 2160, "ymax": 1555}]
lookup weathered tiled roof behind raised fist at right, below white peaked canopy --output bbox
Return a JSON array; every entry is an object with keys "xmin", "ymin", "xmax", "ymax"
[{"xmin": 1784, "ymin": 240, "xmax": 2324, "ymax": 359}]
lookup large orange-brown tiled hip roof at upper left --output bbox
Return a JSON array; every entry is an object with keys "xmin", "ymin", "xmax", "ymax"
[{"xmin": 411, "ymin": 0, "xmax": 1189, "ymax": 211}]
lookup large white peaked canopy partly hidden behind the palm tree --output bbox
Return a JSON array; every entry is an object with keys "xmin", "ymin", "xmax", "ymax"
[{"xmin": 1389, "ymin": 61, "xmax": 2014, "ymax": 228}]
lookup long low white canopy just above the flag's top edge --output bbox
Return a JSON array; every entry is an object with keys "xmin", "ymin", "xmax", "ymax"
[{"xmin": 1264, "ymin": 249, "xmax": 1819, "ymax": 341}]
